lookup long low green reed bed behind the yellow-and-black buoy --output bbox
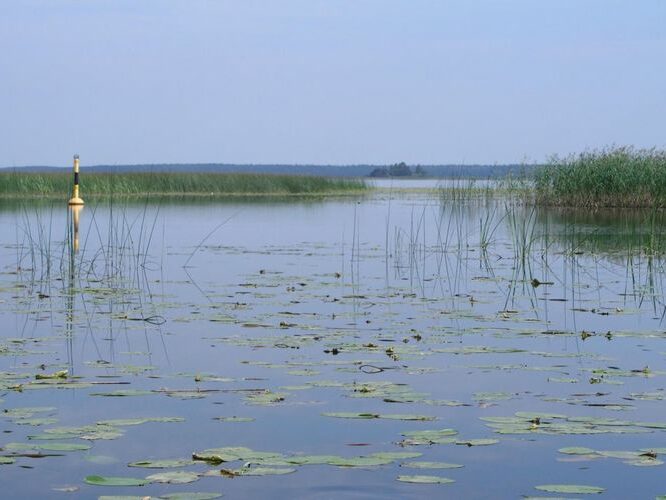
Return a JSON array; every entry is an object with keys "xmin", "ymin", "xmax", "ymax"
[{"xmin": 0, "ymin": 170, "xmax": 366, "ymax": 198}]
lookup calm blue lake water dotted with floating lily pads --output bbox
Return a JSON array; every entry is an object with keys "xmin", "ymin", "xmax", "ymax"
[{"xmin": 0, "ymin": 184, "xmax": 666, "ymax": 499}]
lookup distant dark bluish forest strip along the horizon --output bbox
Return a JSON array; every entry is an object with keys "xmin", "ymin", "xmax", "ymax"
[{"xmin": 2, "ymin": 162, "xmax": 536, "ymax": 179}]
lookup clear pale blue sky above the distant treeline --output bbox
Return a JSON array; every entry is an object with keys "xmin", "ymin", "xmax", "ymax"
[{"xmin": 0, "ymin": 0, "xmax": 666, "ymax": 166}]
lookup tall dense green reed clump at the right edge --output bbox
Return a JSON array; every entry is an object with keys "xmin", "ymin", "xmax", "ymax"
[{"xmin": 535, "ymin": 147, "xmax": 666, "ymax": 208}]
